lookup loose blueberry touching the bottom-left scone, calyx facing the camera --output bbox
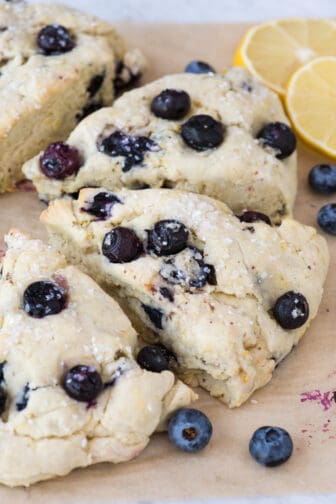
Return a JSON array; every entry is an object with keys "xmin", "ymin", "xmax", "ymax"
[{"xmin": 168, "ymin": 408, "xmax": 212, "ymax": 453}]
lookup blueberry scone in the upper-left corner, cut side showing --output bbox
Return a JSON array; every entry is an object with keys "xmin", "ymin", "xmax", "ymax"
[{"xmin": 0, "ymin": 3, "xmax": 143, "ymax": 192}]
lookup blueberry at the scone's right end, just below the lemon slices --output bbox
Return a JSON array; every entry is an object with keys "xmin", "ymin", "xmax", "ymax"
[{"xmin": 257, "ymin": 122, "xmax": 296, "ymax": 159}]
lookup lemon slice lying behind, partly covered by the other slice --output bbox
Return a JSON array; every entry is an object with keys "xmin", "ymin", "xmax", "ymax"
[{"xmin": 234, "ymin": 19, "xmax": 336, "ymax": 95}]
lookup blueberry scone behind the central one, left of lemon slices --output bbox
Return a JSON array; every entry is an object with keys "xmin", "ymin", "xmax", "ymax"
[{"xmin": 27, "ymin": 68, "xmax": 297, "ymax": 222}]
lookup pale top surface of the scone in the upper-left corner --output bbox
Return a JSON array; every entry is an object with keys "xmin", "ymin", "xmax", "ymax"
[{"xmin": 0, "ymin": 3, "xmax": 125, "ymax": 135}]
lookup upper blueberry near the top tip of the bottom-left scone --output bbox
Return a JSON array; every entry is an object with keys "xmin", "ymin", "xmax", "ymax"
[{"xmin": 23, "ymin": 281, "xmax": 67, "ymax": 318}]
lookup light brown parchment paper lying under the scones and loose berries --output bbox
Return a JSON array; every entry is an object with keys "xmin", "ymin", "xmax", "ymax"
[{"xmin": 0, "ymin": 24, "xmax": 336, "ymax": 504}]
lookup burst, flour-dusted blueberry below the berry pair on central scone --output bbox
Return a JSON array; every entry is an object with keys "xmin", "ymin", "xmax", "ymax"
[{"xmin": 160, "ymin": 247, "xmax": 217, "ymax": 290}]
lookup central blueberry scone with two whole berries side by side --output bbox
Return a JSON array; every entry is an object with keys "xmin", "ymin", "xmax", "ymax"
[{"xmin": 42, "ymin": 189, "xmax": 329, "ymax": 407}]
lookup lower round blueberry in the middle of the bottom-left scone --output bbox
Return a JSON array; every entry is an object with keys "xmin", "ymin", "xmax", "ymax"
[{"xmin": 63, "ymin": 364, "xmax": 104, "ymax": 402}]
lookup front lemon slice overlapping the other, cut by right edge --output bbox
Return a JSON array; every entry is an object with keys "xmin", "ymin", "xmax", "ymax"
[{"xmin": 286, "ymin": 57, "xmax": 336, "ymax": 158}]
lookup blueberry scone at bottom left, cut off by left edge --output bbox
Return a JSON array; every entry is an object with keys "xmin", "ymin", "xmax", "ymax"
[{"xmin": 0, "ymin": 230, "xmax": 194, "ymax": 486}]
